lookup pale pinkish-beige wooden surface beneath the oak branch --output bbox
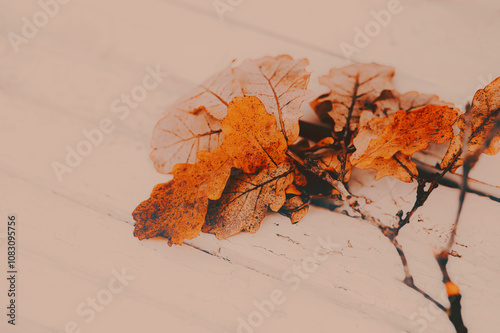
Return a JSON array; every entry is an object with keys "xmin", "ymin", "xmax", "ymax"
[{"xmin": 0, "ymin": 0, "xmax": 500, "ymax": 333}]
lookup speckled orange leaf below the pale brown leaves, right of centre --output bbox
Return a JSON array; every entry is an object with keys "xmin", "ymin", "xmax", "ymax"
[{"xmin": 351, "ymin": 105, "xmax": 457, "ymax": 182}]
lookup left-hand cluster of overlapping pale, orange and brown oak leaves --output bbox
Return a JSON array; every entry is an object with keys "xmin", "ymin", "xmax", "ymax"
[{"xmin": 133, "ymin": 55, "xmax": 310, "ymax": 245}]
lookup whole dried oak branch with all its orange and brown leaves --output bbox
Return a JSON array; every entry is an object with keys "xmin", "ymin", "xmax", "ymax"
[{"xmin": 133, "ymin": 55, "xmax": 500, "ymax": 332}]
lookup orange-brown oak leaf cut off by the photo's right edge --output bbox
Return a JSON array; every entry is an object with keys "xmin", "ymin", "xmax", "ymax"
[{"xmin": 441, "ymin": 77, "xmax": 500, "ymax": 172}]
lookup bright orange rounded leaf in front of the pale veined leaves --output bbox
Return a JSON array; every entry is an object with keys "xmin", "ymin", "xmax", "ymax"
[{"xmin": 222, "ymin": 96, "xmax": 287, "ymax": 173}]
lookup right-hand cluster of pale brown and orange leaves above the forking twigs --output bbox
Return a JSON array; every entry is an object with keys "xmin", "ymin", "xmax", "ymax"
[{"xmin": 311, "ymin": 64, "xmax": 457, "ymax": 182}]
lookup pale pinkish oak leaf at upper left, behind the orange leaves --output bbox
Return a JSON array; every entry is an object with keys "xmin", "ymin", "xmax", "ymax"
[{"xmin": 150, "ymin": 67, "xmax": 237, "ymax": 174}]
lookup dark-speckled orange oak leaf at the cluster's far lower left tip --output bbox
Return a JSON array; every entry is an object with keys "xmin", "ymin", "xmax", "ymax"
[{"xmin": 132, "ymin": 147, "xmax": 233, "ymax": 245}]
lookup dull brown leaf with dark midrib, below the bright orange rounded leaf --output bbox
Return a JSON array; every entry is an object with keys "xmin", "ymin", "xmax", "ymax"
[{"xmin": 203, "ymin": 162, "xmax": 294, "ymax": 239}]
